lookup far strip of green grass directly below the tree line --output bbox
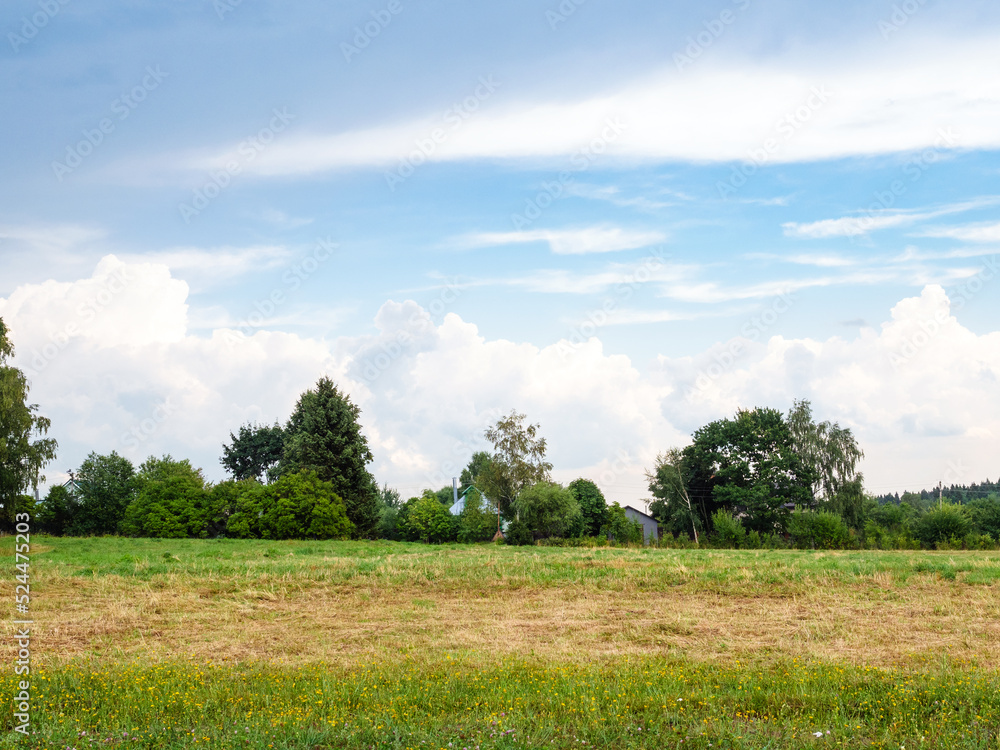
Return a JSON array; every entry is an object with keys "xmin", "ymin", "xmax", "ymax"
[{"xmin": 36, "ymin": 537, "xmax": 1000, "ymax": 593}]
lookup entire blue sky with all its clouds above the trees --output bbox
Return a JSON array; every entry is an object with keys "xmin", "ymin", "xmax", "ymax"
[{"xmin": 0, "ymin": 0, "xmax": 1000, "ymax": 502}]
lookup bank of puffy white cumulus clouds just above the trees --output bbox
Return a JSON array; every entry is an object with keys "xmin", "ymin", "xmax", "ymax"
[{"xmin": 0, "ymin": 256, "xmax": 1000, "ymax": 503}]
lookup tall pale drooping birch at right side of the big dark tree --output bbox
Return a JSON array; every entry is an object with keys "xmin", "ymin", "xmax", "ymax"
[{"xmin": 787, "ymin": 400, "xmax": 865, "ymax": 528}]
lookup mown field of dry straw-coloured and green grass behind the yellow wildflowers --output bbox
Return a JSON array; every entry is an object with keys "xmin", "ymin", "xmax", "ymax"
[{"xmin": 7, "ymin": 539, "xmax": 1000, "ymax": 668}]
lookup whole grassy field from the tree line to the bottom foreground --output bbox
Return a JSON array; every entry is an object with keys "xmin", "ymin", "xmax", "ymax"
[{"xmin": 0, "ymin": 537, "xmax": 1000, "ymax": 749}]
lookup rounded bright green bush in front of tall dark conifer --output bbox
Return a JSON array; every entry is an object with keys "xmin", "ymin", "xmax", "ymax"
[{"xmin": 260, "ymin": 469, "xmax": 353, "ymax": 539}]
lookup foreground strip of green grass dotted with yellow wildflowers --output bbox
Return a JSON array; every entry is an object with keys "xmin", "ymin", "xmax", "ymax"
[{"xmin": 0, "ymin": 656, "xmax": 1000, "ymax": 749}]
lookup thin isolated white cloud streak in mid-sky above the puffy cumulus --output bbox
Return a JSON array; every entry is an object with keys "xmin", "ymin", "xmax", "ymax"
[{"xmin": 457, "ymin": 226, "xmax": 667, "ymax": 255}]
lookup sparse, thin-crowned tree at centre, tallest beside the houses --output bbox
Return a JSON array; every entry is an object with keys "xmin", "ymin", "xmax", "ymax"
[{"xmin": 477, "ymin": 411, "xmax": 552, "ymax": 519}]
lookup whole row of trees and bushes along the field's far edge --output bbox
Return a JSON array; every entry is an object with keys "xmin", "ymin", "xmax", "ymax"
[{"xmin": 0, "ymin": 320, "xmax": 1000, "ymax": 548}]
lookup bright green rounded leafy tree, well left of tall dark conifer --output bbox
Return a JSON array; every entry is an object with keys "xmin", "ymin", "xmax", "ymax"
[{"xmin": 120, "ymin": 455, "xmax": 225, "ymax": 539}]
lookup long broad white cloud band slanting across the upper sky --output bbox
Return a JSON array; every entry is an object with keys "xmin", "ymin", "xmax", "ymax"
[{"xmin": 170, "ymin": 34, "xmax": 1000, "ymax": 175}]
